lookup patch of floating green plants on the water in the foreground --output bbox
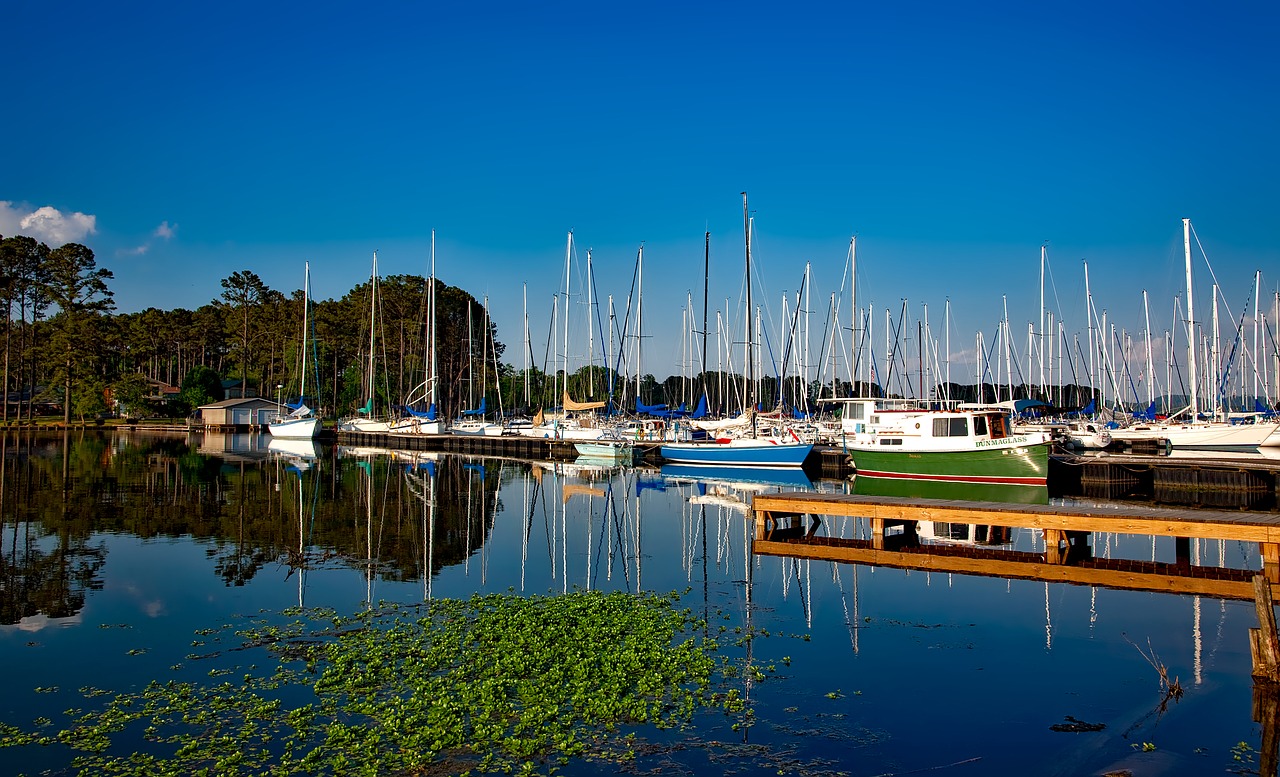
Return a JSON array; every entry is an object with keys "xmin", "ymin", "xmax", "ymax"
[{"xmin": 0, "ymin": 591, "xmax": 744, "ymax": 777}]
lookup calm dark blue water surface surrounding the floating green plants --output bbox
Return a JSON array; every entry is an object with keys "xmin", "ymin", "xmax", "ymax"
[{"xmin": 0, "ymin": 433, "xmax": 1261, "ymax": 776}]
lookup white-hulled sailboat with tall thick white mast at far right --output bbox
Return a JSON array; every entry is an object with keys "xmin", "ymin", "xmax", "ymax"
[{"xmin": 1111, "ymin": 219, "xmax": 1280, "ymax": 449}]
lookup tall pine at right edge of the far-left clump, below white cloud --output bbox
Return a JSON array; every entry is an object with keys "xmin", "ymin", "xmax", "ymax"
[{"xmin": 44, "ymin": 243, "xmax": 114, "ymax": 424}]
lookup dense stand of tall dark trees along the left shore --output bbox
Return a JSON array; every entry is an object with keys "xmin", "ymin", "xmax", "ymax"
[{"xmin": 0, "ymin": 236, "xmax": 524, "ymax": 422}]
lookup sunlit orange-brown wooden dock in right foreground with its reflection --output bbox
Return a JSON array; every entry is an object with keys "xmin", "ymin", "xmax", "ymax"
[{"xmin": 751, "ymin": 492, "xmax": 1280, "ymax": 599}]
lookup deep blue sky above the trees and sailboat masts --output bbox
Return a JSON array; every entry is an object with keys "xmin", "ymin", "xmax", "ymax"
[{"xmin": 0, "ymin": 0, "xmax": 1280, "ymax": 386}]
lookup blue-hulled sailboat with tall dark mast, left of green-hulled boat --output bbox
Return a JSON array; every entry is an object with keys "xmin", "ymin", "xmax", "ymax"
[{"xmin": 662, "ymin": 192, "xmax": 813, "ymax": 467}]
